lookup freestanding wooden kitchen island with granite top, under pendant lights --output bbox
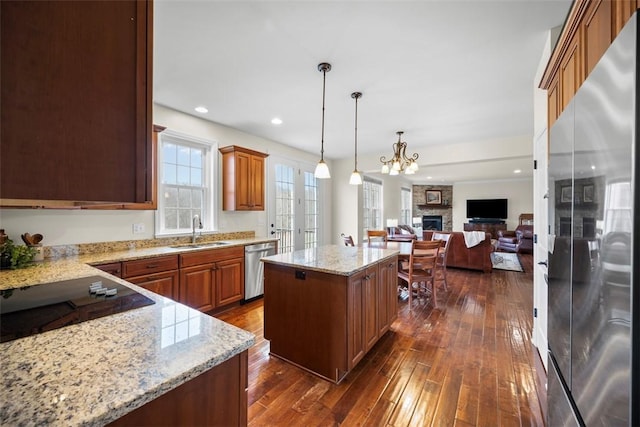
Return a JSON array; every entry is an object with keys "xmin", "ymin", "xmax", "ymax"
[{"xmin": 262, "ymin": 245, "xmax": 398, "ymax": 383}]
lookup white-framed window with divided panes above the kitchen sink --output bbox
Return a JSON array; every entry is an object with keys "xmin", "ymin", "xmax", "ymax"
[{"xmin": 156, "ymin": 130, "xmax": 215, "ymax": 234}]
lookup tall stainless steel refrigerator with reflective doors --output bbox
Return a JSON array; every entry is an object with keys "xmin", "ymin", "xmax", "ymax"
[{"xmin": 547, "ymin": 13, "xmax": 640, "ymax": 427}]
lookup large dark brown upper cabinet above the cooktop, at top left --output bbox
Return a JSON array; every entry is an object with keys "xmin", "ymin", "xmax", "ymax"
[{"xmin": 0, "ymin": 0, "xmax": 155, "ymax": 209}]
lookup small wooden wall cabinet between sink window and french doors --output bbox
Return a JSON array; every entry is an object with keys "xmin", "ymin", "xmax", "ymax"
[{"xmin": 220, "ymin": 145, "xmax": 268, "ymax": 211}]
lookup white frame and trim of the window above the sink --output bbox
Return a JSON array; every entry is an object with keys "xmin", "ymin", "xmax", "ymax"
[{"xmin": 155, "ymin": 129, "xmax": 219, "ymax": 237}]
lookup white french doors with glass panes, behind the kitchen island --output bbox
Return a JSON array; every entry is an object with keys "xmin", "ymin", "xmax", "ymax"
[{"xmin": 268, "ymin": 156, "xmax": 320, "ymax": 253}]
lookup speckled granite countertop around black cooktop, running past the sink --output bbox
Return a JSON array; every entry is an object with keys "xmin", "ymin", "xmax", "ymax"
[{"xmin": 0, "ymin": 238, "xmax": 269, "ymax": 426}]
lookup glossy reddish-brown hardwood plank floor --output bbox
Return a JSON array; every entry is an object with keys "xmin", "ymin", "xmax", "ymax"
[{"xmin": 217, "ymin": 255, "xmax": 544, "ymax": 426}]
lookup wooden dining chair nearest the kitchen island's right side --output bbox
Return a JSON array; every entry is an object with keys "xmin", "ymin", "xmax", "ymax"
[{"xmin": 398, "ymin": 240, "xmax": 442, "ymax": 310}]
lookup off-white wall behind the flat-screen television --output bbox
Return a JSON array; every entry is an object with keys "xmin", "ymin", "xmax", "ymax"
[{"xmin": 452, "ymin": 178, "xmax": 533, "ymax": 231}]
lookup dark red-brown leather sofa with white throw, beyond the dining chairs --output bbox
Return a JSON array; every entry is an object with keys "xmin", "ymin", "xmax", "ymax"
[{"xmin": 422, "ymin": 230, "xmax": 493, "ymax": 273}]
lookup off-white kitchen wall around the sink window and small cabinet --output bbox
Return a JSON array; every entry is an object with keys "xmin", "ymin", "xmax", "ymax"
[{"xmin": 0, "ymin": 105, "xmax": 330, "ymax": 246}]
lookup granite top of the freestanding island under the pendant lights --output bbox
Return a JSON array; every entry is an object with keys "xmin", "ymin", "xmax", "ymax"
[{"xmin": 262, "ymin": 245, "xmax": 400, "ymax": 276}]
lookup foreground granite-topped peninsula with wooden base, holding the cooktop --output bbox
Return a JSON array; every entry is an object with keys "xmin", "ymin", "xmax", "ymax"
[{"xmin": 0, "ymin": 258, "xmax": 254, "ymax": 426}]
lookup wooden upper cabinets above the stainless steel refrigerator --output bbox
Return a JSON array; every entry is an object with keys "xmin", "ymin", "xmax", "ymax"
[{"xmin": 540, "ymin": 0, "xmax": 640, "ymax": 127}]
